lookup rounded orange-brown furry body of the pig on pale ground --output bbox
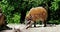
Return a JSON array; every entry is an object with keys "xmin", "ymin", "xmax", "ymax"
[{"xmin": 25, "ymin": 7, "xmax": 48, "ymax": 26}]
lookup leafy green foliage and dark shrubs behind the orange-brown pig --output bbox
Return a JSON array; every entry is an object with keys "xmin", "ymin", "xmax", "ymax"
[{"xmin": 0, "ymin": 0, "xmax": 60, "ymax": 24}]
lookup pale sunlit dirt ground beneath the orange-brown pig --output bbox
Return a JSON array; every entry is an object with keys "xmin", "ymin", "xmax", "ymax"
[{"xmin": 0, "ymin": 24, "xmax": 60, "ymax": 32}]
